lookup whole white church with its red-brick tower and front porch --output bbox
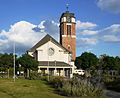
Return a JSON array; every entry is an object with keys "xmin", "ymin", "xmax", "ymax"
[{"xmin": 28, "ymin": 11, "xmax": 76, "ymax": 78}]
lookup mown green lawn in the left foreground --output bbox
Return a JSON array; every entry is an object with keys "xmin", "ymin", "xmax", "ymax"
[{"xmin": 0, "ymin": 79, "xmax": 66, "ymax": 98}]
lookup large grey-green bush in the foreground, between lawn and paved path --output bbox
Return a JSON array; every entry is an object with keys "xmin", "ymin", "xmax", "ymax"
[{"xmin": 59, "ymin": 78, "xmax": 102, "ymax": 97}]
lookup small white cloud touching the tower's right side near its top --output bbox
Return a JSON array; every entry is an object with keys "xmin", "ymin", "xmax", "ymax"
[{"xmin": 76, "ymin": 20, "xmax": 97, "ymax": 29}]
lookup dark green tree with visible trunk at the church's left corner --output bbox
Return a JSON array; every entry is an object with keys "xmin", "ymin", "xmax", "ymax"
[{"xmin": 18, "ymin": 54, "xmax": 38, "ymax": 78}]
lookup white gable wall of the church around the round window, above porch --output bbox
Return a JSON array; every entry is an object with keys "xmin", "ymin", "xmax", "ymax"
[{"xmin": 37, "ymin": 41, "xmax": 69, "ymax": 63}]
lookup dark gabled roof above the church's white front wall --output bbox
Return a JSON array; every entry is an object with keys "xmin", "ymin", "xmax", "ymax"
[{"xmin": 28, "ymin": 34, "xmax": 71, "ymax": 53}]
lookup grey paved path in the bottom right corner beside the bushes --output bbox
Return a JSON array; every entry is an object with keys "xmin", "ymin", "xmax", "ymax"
[{"xmin": 104, "ymin": 90, "xmax": 120, "ymax": 98}]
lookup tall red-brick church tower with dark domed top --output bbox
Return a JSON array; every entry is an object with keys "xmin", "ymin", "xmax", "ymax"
[{"xmin": 60, "ymin": 10, "xmax": 76, "ymax": 60}]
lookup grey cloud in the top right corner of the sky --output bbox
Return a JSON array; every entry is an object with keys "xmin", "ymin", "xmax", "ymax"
[{"xmin": 97, "ymin": 0, "xmax": 120, "ymax": 13}]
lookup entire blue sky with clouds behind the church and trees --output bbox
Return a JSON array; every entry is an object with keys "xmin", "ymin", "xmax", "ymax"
[{"xmin": 0, "ymin": 0, "xmax": 120, "ymax": 56}]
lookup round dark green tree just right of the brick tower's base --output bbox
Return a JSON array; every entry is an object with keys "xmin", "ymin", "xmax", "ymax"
[{"xmin": 75, "ymin": 52, "xmax": 98, "ymax": 70}]
